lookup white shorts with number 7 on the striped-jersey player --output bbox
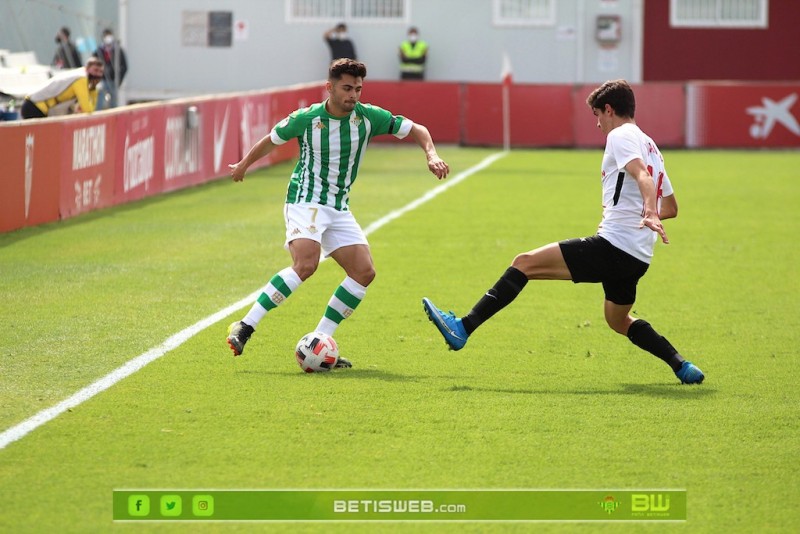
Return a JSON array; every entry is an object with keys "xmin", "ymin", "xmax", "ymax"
[{"xmin": 283, "ymin": 203, "xmax": 369, "ymax": 257}]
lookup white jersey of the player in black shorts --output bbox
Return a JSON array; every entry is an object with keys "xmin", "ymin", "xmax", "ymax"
[{"xmin": 597, "ymin": 123, "xmax": 673, "ymax": 263}]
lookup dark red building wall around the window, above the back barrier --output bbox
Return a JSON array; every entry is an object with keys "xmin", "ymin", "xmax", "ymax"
[{"xmin": 643, "ymin": 0, "xmax": 800, "ymax": 82}]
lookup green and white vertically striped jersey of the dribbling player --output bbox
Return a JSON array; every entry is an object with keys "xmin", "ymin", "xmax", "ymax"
[{"xmin": 270, "ymin": 102, "xmax": 414, "ymax": 211}]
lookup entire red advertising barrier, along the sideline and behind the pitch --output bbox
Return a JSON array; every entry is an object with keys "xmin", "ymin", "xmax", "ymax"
[{"xmin": 0, "ymin": 82, "xmax": 800, "ymax": 232}]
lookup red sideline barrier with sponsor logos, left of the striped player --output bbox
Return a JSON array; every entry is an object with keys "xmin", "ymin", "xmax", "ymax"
[{"xmin": 0, "ymin": 84, "xmax": 322, "ymax": 232}]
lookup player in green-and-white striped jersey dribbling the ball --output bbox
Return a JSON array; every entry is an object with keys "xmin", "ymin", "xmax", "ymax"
[{"xmin": 227, "ymin": 58, "xmax": 450, "ymax": 367}]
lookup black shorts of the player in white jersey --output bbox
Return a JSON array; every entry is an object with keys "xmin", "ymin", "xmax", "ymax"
[{"xmin": 558, "ymin": 235, "xmax": 650, "ymax": 306}]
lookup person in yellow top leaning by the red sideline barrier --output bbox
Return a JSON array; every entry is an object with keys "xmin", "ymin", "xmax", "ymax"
[{"xmin": 20, "ymin": 56, "xmax": 103, "ymax": 119}]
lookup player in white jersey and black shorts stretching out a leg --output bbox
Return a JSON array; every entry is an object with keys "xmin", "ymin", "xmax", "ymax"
[{"xmin": 422, "ymin": 80, "xmax": 705, "ymax": 384}]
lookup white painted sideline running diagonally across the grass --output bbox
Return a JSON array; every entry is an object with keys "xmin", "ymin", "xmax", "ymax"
[{"xmin": 0, "ymin": 152, "xmax": 508, "ymax": 450}]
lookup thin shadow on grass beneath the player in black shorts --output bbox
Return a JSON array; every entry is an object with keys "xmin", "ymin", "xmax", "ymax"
[{"xmin": 444, "ymin": 384, "xmax": 717, "ymax": 400}]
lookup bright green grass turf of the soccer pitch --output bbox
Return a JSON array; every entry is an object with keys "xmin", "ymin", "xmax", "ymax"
[{"xmin": 0, "ymin": 147, "xmax": 800, "ymax": 532}]
